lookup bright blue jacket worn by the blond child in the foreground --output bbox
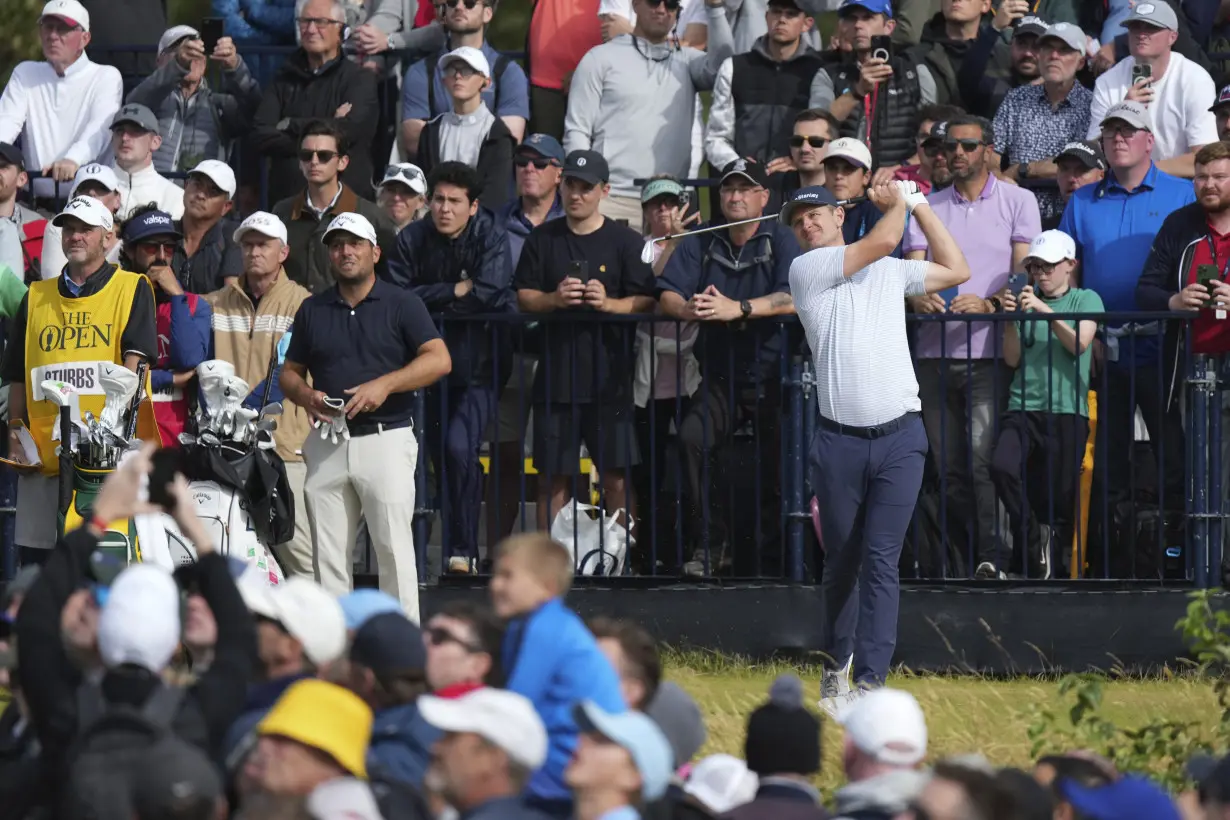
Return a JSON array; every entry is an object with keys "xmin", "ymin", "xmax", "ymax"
[{"xmin": 502, "ymin": 597, "xmax": 626, "ymax": 800}]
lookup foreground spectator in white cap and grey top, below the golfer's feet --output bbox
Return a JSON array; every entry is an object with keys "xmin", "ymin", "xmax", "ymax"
[{"xmin": 834, "ymin": 688, "xmax": 926, "ymax": 820}]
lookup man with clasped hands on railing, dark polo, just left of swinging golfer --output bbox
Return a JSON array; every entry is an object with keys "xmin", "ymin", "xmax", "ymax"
[{"xmin": 658, "ymin": 160, "xmax": 798, "ymax": 575}]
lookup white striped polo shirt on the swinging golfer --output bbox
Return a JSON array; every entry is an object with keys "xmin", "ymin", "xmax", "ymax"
[{"xmin": 790, "ymin": 246, "xmax": 929, "ymax": 427}]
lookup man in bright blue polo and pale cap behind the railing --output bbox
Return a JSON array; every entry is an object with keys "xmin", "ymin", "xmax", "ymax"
[{"xmin": 1059, "ymin": 101, "xmax": 1196, "ymax": 569}]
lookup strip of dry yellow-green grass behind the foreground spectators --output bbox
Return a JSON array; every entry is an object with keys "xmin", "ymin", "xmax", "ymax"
[{"xmin": 667, "ymin": 653, "xmax": 1218, "ymax": 797}]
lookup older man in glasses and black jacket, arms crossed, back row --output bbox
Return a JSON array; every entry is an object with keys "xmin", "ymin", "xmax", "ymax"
[{"xmin": 252, "ymin": 0, "xmax": 379, "ymax": 202}]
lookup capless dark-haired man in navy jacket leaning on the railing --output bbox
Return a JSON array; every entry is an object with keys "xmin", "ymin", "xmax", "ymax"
[{"xmin": 389, "ymin": 162, "xmax": 515, "ymax": 573}]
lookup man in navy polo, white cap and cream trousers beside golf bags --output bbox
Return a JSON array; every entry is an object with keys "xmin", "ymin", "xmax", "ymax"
[{"xmin": 280, "ymin": 214, "xmax": 453, "ymax": 622}]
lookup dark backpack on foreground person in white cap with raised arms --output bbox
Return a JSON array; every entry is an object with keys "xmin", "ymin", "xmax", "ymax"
[{"xmin": 64, "ymin": 684, "xmax": 189, "ymax": 820}]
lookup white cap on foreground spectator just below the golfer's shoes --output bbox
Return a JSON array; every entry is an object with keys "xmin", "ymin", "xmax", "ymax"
[{"xmin": 838, "ymin": 688, "xmax": 926, "ymax": 766}]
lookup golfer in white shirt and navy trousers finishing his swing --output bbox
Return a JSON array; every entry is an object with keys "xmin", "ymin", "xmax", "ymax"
[{"xmin": 781, "ymin": 182, "xmax": 969, "ymax": 717}]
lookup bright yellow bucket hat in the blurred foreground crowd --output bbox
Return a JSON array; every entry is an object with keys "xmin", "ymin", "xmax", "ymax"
[{"xmin": 256, "ymin": 679, "xmax": 371, "ymax": 778}]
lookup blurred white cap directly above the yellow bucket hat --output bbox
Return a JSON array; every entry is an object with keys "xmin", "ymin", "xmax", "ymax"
[{"xmin": 236, "ymin": 574, "xmax": 346, "ymax": 666}]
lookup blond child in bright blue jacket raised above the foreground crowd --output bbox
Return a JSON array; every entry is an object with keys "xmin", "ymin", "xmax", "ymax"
[{"xmin": 491, "ymin": 532, "xmax": 626, "ymax": 818}]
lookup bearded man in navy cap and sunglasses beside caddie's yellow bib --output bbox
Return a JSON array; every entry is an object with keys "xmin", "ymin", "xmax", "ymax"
[{"xmin": 121, "ymin": 205, "xmax": 210, "ymax": 446}]
